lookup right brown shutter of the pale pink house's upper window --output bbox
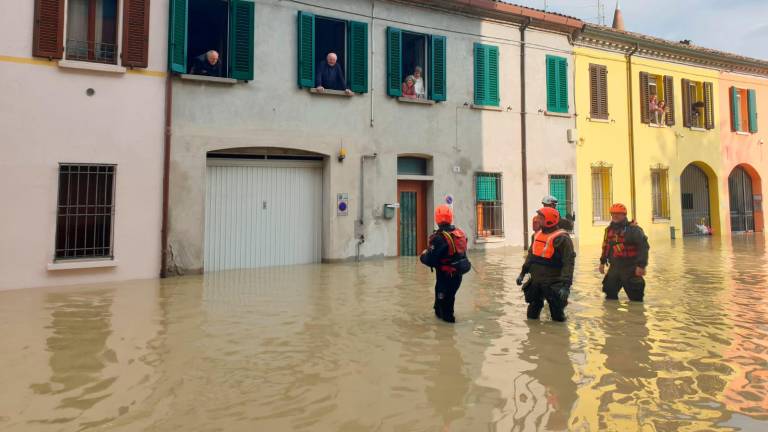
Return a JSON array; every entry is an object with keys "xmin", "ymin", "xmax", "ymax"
[{"xmin": 121, "ymin": 0, "xmax": 149, "ymax": 68}]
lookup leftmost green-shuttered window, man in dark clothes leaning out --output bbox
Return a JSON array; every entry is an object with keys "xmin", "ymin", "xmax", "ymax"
[{"xmin": 168, "ymin": 0, "xmax": 255, "ymax": 81}]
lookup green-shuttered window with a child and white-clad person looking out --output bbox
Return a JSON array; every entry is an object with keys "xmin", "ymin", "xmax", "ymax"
[{"xmin": 387, "ymin": 27, "xmax": 447, "ymax": 102}]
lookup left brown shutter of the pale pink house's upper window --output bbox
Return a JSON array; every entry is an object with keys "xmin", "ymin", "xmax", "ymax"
[{"xmin": 32, "ymin": 0, "xmax": 64, "ymax": 59}]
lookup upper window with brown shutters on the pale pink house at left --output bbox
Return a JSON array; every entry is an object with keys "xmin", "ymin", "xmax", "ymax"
[{"xmin": 32, "ymin": 0, "xmax": 149, "ymax": 68}]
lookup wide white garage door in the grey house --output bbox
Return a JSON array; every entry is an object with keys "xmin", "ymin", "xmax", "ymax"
[{"xmin": 204, "ymin": 159, "xmax": 323, "ymax": 271}]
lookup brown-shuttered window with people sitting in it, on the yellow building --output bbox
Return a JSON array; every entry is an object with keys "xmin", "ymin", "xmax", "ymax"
[{"xmin": 640, "ymin": 72, "xmax": 675, "ymax": 126}]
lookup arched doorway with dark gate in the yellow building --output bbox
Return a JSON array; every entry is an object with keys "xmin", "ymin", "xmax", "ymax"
[{"xmin": 680, "ymin": 164, "xmax": 712, "ymax": 235}]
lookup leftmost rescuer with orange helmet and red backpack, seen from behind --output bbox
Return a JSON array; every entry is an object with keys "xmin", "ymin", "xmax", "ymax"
[{"xmin": 419, "ymin": 204, "xmax": 472, "ymax": 323}]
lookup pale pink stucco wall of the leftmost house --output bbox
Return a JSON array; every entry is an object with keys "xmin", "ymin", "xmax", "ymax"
[{"xmin": 0, "ymin": 0, "xmax": 168, "ymax": 290}]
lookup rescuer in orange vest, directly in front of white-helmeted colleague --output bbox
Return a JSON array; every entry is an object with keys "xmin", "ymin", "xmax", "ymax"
[{"xmin": 517, "ymin": 207, "xmax": 576, "ymax": 321}]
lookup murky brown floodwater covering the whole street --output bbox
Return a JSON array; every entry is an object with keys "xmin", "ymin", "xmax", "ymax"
[{"xmin": 0, "ymin": 235, "xmax": 768, "ymax": 432}]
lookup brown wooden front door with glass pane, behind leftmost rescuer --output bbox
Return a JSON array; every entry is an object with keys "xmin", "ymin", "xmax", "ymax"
[{"xmin": 397, "ymin": 180, "xmax": 427, "ymax": 256}]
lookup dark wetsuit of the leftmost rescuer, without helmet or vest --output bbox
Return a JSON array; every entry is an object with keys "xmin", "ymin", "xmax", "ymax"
[{"xmin": 419, "ymin": 225, "xmax": 462, "ymax": 322}]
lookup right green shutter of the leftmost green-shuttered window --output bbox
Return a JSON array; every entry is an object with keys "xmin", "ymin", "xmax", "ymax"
[{"xmin": 229, "ymin": 0, "xmax": 255, "ymax": 81}]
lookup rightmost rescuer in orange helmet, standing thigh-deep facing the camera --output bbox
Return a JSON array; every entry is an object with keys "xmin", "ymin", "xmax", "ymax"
[{"xmin": 599, "ymin": 203, "xmax": 650, "ymax": 302}]
